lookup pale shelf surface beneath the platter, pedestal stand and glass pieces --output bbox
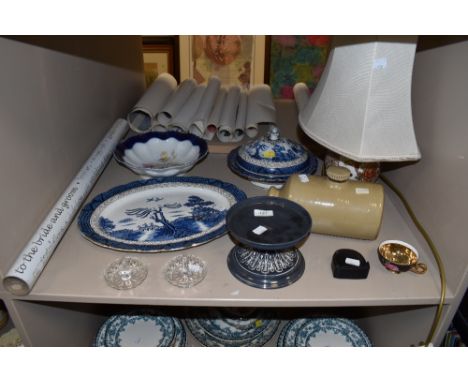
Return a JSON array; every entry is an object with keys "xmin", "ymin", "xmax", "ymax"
[{"xmin": 13, "ymin": 154, "xmax": 452, "ymax": 307}]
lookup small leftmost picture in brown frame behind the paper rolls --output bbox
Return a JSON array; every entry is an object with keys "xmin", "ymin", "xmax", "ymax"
[{"xmin": 143, "ymin": 36, "xmax": 179, "ymax": 87}]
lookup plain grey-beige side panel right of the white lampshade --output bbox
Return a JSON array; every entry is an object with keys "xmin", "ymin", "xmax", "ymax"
[{"xmin": 388, "ymin": 42, "xmax": 468, "ymax": 300}]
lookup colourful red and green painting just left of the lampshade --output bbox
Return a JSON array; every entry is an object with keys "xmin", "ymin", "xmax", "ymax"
[{"xmin": 269, "ymin": 36, "xmax": 331, "ymax": 98}]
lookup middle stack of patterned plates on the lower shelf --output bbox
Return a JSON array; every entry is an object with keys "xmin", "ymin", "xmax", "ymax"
[{"xmin": 185, "ymin": 309, "xmax": 280, "ymax": 347}]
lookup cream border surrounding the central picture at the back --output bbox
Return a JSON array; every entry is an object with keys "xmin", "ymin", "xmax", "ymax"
[{"xmin": 179, "ymin": 35, "xmax": 265, "ymax": 87}]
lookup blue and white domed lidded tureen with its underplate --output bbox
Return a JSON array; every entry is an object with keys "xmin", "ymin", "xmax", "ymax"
[{"xmin": 228, "ymin": 127, "xmax": 317, "ymax": 182}]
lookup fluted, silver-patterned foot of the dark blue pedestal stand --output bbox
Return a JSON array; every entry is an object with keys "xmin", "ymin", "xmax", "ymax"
[{"xmin": 227, "ymin": 245, "xmax": 305, "ymax": 289}]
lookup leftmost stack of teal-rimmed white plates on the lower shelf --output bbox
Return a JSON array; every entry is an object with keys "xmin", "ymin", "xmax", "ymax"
[{"xmin": 93, "ymin": 313, "xmax": 186, "ymax": 347}]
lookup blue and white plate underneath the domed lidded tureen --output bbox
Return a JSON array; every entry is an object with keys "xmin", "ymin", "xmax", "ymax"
[{"xmin": 227, "ymin": 148, "xmax": 318, "ymax": 184}]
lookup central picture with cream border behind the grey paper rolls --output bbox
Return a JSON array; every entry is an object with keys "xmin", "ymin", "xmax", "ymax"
[{"xmin": 179, "ymin": 35, "xmax": 265, "ymax": 89}]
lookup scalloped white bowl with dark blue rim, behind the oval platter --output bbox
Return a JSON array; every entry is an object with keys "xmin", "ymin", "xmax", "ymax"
[{"xmin": 114, "ymin": 131, "xmax": 208, "ymax": 177}]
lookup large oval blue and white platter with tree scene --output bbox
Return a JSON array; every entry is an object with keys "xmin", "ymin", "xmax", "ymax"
[{"xmin": 78, "ymin": 177, "xmax": 246, "ymax": 252}]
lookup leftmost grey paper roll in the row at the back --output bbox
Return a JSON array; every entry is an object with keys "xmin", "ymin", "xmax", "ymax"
[{"xmin": 127, "ymin": 73, "xmax": 177, "ymax": 133}]
